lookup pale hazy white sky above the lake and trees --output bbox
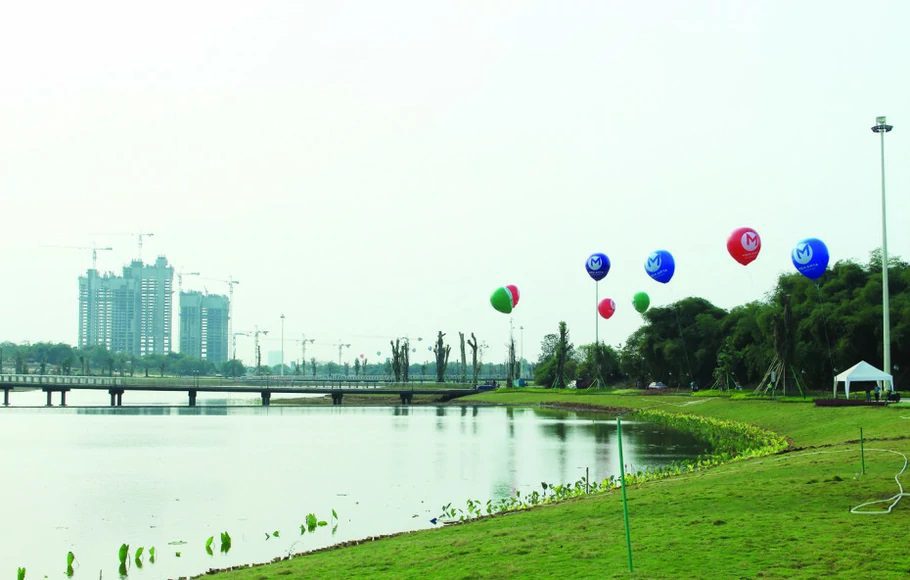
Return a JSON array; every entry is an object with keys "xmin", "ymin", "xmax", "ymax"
[{"xmin": 0, "ymin": 0, "xmax": 910, "ymax": 362}]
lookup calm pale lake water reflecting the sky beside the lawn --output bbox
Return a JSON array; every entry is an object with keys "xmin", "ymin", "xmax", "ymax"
[{"xmin": 0, "ymin": 392, "xmax": 706, "ymax": 579}]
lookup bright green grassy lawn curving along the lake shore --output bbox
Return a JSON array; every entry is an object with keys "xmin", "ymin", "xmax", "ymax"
[{"xmin": 201, "ymin": 390, "xmax": 910, "ymax": 579}]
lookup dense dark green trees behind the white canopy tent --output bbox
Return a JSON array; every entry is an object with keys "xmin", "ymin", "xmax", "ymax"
[{"xmin": 534, "ymin": 251, "xmax": 910, "ymax": 390}]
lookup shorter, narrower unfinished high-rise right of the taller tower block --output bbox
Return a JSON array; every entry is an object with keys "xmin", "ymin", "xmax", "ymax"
[{"xmin": 180, "ymin": 292, "xmax": 230, "ymax": 365}]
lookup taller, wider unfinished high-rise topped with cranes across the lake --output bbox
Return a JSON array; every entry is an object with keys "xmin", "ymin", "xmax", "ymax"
[{"xmin": 79, "ymin": 256, "xmax": 174, "ymax": 356}]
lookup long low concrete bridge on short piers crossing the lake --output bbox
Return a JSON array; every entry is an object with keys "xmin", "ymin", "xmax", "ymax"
[{"xmin": 0, "ymin": 374, "xmax": 488, "ymax": 407}]
